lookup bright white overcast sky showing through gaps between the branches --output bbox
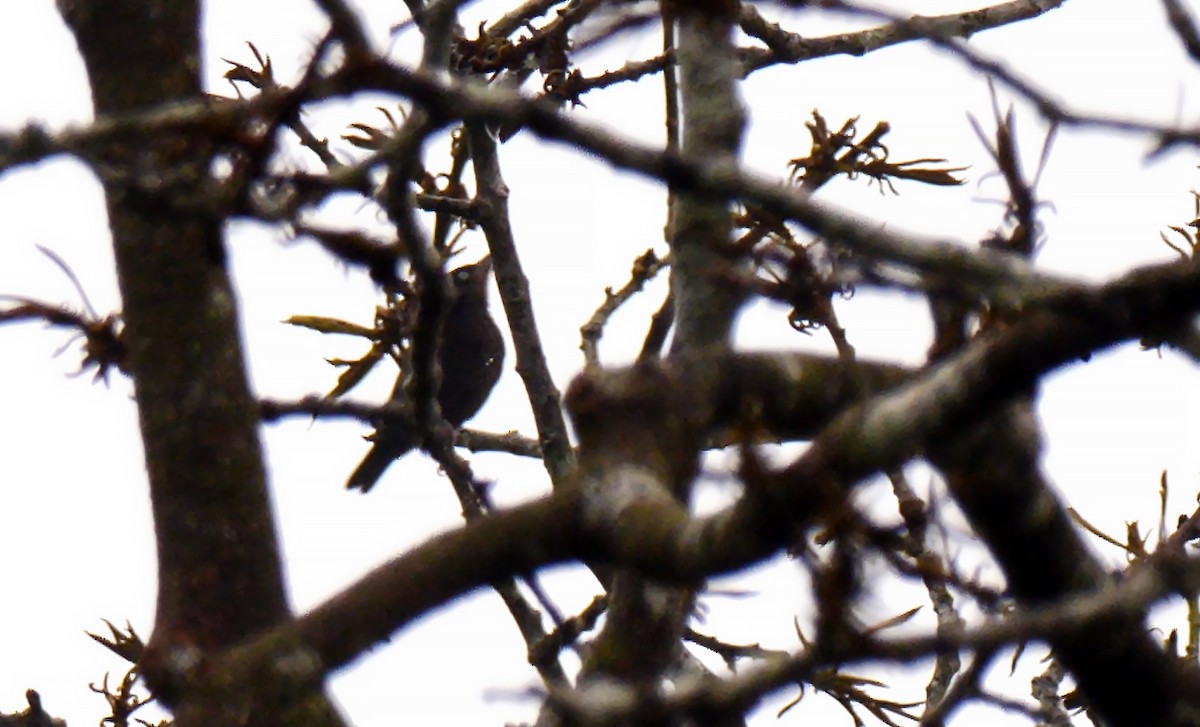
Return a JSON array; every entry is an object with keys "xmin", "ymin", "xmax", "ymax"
[{"xmin": 0, "ymin": 0, "xmax": 1200, "ymax": 726}]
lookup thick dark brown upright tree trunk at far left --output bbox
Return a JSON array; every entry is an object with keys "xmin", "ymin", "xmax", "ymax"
[{"xmin": 59, "ymin": 0, "xmax": 335, "ymax": 725}]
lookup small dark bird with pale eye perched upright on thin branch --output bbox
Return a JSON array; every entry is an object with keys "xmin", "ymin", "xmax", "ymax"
[{"xmin": 346, "ymin": 257, "xmax": 504, "ymax": 492}]
